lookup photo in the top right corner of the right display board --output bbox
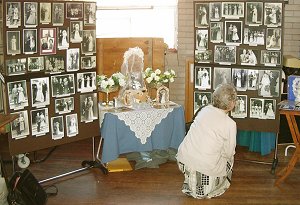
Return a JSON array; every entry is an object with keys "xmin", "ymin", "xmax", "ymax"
[{"xmin": 264, "ymin": 2, "xmax": 282, "ymax": 27}]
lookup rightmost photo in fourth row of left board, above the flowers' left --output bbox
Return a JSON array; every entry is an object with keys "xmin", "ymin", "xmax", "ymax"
[{"xmin": 77, "ymin": 72, "xmax": 97, "ymax": 93}]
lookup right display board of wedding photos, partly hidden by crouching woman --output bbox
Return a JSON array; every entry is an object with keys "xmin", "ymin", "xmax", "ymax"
[{"xmin": 193, "ymin": 0, "xmax": 284, "ymax": 133}]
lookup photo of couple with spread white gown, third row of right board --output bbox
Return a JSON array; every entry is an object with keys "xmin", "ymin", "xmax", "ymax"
[{"xmin": 238, "ymin": 47, "xmax": 260, "ymax": 66}]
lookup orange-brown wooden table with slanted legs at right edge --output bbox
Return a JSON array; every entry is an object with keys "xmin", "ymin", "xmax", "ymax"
[{"xmin": 275, "ymin": 110, "xmax": 300, "ymax": 186}]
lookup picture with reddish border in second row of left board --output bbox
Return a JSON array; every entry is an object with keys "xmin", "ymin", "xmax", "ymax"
[{"xmin": 40, "ymin": 28, "xmax": 56, "ymax": 55}]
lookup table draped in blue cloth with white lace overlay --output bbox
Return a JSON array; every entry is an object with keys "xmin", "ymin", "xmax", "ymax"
[{"xmin": 97, "ymin": 105, "xmax": 185, "ymax": 163}]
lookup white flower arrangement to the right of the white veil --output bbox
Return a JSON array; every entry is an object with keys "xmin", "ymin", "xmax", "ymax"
[{"xmin": 143, "ymin": 68, "xmax": 176, "ymax": 84}]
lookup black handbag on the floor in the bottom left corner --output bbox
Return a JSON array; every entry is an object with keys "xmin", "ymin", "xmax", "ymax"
[{"xmin": 7, "ymin": 169, "xmax": 47, "ymax": 205}]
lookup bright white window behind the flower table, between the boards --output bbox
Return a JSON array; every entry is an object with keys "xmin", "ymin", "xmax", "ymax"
[{"xmin": 96, "ymin": 0, "xmax": 177, "ymax": 48}]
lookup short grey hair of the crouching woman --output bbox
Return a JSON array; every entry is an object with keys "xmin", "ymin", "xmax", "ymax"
[{"xmin": 212, "ymin": 84, "xmax": 237, "ymax": 110}]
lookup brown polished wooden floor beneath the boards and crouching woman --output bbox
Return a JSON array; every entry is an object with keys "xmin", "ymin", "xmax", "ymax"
[{"xmin": 0, "ymin": 139, "xmax": 300, "ymax": 205}]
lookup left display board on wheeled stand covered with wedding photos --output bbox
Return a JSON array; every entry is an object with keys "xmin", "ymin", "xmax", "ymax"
[{"xmin": 0, "ymin": 0, "xmax": 100, "ymax": 155}]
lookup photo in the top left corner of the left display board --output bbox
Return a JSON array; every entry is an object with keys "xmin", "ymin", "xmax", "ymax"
[{"xmin": 6, "ymin": 2, "xmax": 22, "ymax": 28}]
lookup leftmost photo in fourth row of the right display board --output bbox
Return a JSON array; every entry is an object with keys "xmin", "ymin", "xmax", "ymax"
[{"xmin": 194, "ymin": 66, "xmax": 211, "ymax": 90}]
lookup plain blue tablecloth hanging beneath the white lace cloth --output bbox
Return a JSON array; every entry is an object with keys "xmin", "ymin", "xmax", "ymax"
[{"xmin": 101, "ymin": 106, "xmax": 185, "ymax": 163}]
